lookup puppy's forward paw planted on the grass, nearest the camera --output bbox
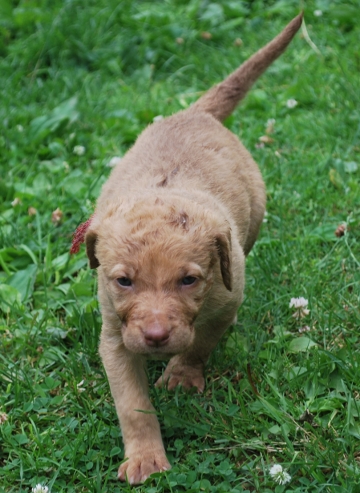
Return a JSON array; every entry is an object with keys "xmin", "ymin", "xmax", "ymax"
[{"xmin": 118, "ymin": 451, "xmax": 171, "ymax": 485}]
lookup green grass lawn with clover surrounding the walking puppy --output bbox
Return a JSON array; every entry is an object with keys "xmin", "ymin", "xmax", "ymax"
[{"xmin": 0, "ymin": 0, "xmax": 360, "ymax": 493}]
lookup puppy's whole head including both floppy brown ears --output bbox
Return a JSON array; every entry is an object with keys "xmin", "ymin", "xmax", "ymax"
[{"xmin": 85, "ymin": 199, "xmax": 232, "ymax": 355}]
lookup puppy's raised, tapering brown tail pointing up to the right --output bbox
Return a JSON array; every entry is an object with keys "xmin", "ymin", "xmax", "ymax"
[{"xmin": 193, "ymin": 12, "xmax": 303, "ymax": 121}]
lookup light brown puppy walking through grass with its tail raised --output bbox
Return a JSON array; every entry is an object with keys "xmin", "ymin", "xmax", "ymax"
[{"xmin": 85, "ymin": 14, "xmax": 302, "ymax": 484}]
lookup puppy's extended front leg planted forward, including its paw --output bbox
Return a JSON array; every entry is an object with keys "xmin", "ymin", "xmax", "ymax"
[{"xmin": 100, "ymin": 327, "xmax": 170, "ymax": 484}]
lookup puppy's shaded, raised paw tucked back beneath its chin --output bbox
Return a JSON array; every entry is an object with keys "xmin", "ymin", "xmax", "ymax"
[{"xmin": 155, "ymin": 364, "xmax": 205, "ymax": 392}]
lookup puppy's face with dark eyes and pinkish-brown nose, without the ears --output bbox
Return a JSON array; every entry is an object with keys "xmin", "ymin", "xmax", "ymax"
[{"xmin": 102, "ymin": 252, "xmax": 213, "ymax": 354}]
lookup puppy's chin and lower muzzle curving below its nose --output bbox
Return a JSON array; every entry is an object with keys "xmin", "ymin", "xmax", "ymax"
[{"xmin": 123, "ymin": 327, "xmax": 195, "ymax": 360}]
